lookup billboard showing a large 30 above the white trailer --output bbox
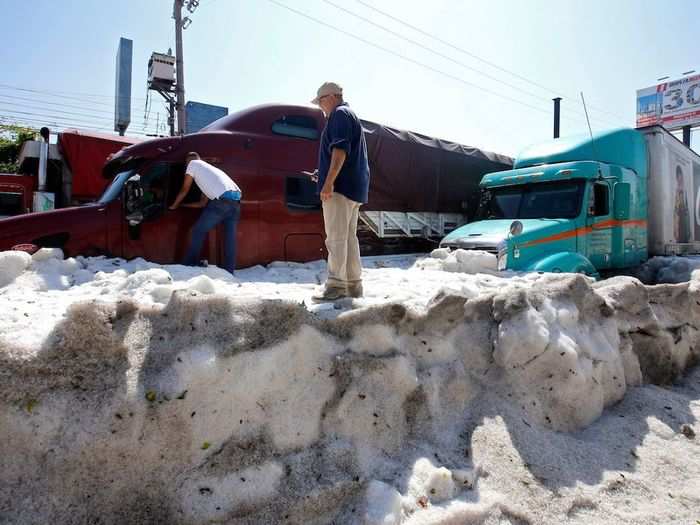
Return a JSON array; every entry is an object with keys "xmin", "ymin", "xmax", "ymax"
[{"xmin": 637, "ymin": 75, "xmax": 700, "ymax": 131}]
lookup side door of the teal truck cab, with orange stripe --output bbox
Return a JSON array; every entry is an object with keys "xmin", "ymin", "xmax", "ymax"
[{"xmin": 583, "ymin": 181, "xmax": 614, "ymax": 270}]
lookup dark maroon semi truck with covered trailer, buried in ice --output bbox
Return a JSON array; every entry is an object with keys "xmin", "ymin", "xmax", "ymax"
[{"xmin": 0, "ymin": 105, "xmax": 512, "ymax": 267}]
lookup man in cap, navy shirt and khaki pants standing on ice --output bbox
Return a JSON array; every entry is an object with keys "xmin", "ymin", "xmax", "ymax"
[{"xmin": 311, "ymin": 82, "xmax": 369, "ymax": 301}]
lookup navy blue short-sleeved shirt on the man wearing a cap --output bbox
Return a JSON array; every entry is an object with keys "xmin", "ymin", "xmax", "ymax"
[{"xmin": 318, "ymin": 102, "xmax": 369, "ymax": 204}]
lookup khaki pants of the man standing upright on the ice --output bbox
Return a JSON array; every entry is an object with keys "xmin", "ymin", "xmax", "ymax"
[{"xmin": 323, "ymin": 193, "xmax": 362, "ymax": 289}]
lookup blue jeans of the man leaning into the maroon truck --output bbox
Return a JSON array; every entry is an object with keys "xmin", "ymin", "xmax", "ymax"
[{"xmin": 183, "ymin": 199, "xmax": 241, "ymax": 273}]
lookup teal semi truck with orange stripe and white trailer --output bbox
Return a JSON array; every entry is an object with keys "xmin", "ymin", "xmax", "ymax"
[{"xmin": 440, "ymin": 126, "xmax": 700, "ymax": 278}]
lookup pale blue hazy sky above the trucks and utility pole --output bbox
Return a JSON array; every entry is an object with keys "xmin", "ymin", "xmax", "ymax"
[{"xmin": 0, "ymin": 0, "xmax": 700, "ymax": 155}]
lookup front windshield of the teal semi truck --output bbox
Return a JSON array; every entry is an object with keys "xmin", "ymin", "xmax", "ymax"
[{"xmin": 477, "ymin": 181, "xmax": 584, "ymax": 220}]
